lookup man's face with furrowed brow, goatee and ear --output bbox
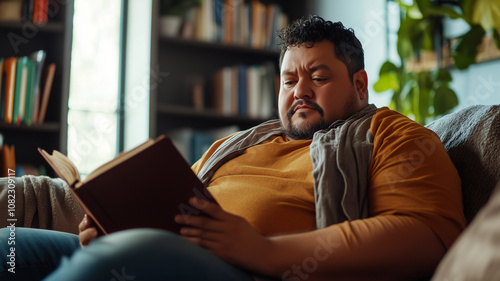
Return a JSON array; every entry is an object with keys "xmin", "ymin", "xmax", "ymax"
[{"xmin": 278, "ymin": 40, "xmax": 368, "ymax": 139}]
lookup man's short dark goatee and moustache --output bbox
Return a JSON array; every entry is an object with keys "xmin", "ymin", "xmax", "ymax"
[{"xmin": 281, "ymin": 100, "xmax": 330, "ymax": 140}]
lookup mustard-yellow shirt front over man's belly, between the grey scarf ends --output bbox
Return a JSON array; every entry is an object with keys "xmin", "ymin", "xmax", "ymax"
[{"xmin": 195, "ymin": 136, "xmax": 316, "ymax": 236}]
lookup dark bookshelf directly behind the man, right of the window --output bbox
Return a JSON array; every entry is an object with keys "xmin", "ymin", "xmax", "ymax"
[{"xmin": 149, "ymin": 0, "xmax": 306, "ymax": 162}]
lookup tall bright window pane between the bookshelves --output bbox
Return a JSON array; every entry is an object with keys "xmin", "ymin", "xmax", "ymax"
[{"xmin": 68, "ymin": 0, "xmax": 123, "ymax": 176}]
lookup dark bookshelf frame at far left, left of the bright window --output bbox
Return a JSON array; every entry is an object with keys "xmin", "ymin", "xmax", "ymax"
[{"xmin": 0, "ymin": 1, "xmax": 74, "ymax": 176}]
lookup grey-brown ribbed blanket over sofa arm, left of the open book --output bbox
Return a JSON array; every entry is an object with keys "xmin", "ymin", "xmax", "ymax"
[{"xmin": 0, "ymin": 176, "xmax": 84, "ymax": 234}]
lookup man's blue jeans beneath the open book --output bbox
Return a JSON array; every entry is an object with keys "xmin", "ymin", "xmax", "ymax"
[{"xmin": 0, "ymin": 228, "xmax": 253, "ymax": 281}]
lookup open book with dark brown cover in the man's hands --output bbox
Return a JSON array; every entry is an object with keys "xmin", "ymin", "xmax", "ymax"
[{"xmin": 38, "ymin": 136, "xmax": 215, "ymax": 234}]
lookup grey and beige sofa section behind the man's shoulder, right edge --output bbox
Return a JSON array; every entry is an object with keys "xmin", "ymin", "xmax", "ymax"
[{"xmin": 427, "ymin": 105, "xmax": 500, "ymax": 281}]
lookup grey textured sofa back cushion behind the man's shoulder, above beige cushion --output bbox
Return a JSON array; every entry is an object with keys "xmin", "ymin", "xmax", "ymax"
[{"xmin": 426, "ymin": 105, "xmax": 500, "ymax": 223}]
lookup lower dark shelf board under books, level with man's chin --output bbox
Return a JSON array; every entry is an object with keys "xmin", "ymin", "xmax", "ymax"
[{"xmin": 157, "ymin": 104, "xmax": 270, "ymax": 124}]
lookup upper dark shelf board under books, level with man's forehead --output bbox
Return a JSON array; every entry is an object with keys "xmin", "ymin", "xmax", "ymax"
[{"xmin": 160, "ymin": 36, "xmax": 280, "ymax": 58}]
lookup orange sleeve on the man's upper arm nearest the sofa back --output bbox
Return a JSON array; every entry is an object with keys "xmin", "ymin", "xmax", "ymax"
[{"xmin": 369, "ymin": 108, "xmax": 465, "ymax": 248}]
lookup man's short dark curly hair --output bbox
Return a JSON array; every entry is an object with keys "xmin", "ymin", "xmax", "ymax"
[{"xmin": 278, "ymin": 15, "xmax": 365, "ymax": 82}]
